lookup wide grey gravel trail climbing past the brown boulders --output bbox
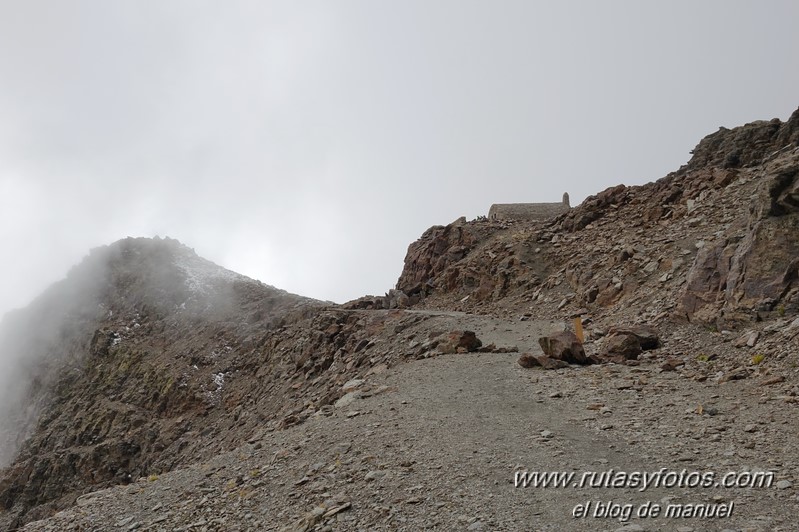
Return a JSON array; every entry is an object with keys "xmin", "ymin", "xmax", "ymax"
[{"xmin": 25, "ymin": 312, "xmax": 797, "ymax": 532}]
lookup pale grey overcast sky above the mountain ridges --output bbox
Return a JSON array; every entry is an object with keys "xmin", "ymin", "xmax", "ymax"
[{"xmin": 0, "ymin": 0, "xmax": 799, "ymax": 312}]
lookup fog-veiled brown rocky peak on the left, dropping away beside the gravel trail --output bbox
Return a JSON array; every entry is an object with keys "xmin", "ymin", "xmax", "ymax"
[{"xmin": 0, "ymin": 239, "xmax": 520, "ymax": 528}]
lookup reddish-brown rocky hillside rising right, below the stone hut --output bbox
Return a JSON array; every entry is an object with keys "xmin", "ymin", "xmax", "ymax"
[{"xmin": 397, "ymin": 111, "xmax": 799, "ymax": 329}]
